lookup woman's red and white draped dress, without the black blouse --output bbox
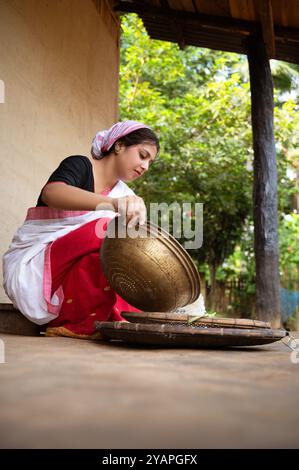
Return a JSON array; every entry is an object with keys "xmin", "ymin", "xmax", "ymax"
[{"xmin": 3, "ymin": 181, "xmax": 141, "ymax": 335}]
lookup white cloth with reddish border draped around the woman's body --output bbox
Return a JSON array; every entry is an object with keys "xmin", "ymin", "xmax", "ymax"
[{"xmin": 3, "ymin": 181, "xmax": 134, "ymax": 325}]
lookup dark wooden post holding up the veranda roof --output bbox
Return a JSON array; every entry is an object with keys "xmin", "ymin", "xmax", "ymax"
[{"xmin": 248, "ymin": 36, "xmax": 280, "ymax": 327}]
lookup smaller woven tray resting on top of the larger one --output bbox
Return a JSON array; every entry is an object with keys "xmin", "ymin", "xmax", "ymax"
[{"xmin": 121, "ymin": 312, "xmax": 271, "ymax": 329}]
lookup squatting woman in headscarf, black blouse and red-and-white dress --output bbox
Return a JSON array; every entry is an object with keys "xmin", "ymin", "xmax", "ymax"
[{"xmin": 3, "ymin": 121, "xmax": 159, "ymax": 339}]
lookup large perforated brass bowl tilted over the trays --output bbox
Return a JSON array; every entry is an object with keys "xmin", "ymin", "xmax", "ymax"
[{"xmin": 100, "ymin": 220, "xmax": 200, "ymax": 312}]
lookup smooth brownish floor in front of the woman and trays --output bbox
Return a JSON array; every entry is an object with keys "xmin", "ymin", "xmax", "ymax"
[{"xmin": 0, "ymin": 335, "xmax": 299, "ymax": 449}]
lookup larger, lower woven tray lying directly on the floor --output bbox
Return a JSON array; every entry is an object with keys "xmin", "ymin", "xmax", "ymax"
[{"xmin": 96, "ymin": 322, "xmax": 286, "ymax": 348}]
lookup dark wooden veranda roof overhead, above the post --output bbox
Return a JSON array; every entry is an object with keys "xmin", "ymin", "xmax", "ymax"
[{"xmin": 113, "ymin": 0, "xmax": 299, "ymax": 63}]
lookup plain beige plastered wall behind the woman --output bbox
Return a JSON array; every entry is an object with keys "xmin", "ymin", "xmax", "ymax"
[{"xmin": 0, "ymin": 0, "xmax": 119, "ymax": 302}]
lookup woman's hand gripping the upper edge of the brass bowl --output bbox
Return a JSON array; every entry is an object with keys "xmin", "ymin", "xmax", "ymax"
[{"xmin": 113, "ymin": 195, "xmax": 146, "ymax": 228}]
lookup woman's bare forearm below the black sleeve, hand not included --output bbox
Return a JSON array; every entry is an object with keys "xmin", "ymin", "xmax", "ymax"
[{"xmin": 41, "ymin": 182, "xmax": 116, "ymax": 211}]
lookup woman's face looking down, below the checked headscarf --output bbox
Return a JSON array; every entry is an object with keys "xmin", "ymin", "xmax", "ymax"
[{"xmin": 115, "ymin": 142, "xmax": 157, "ymax": 181}]
